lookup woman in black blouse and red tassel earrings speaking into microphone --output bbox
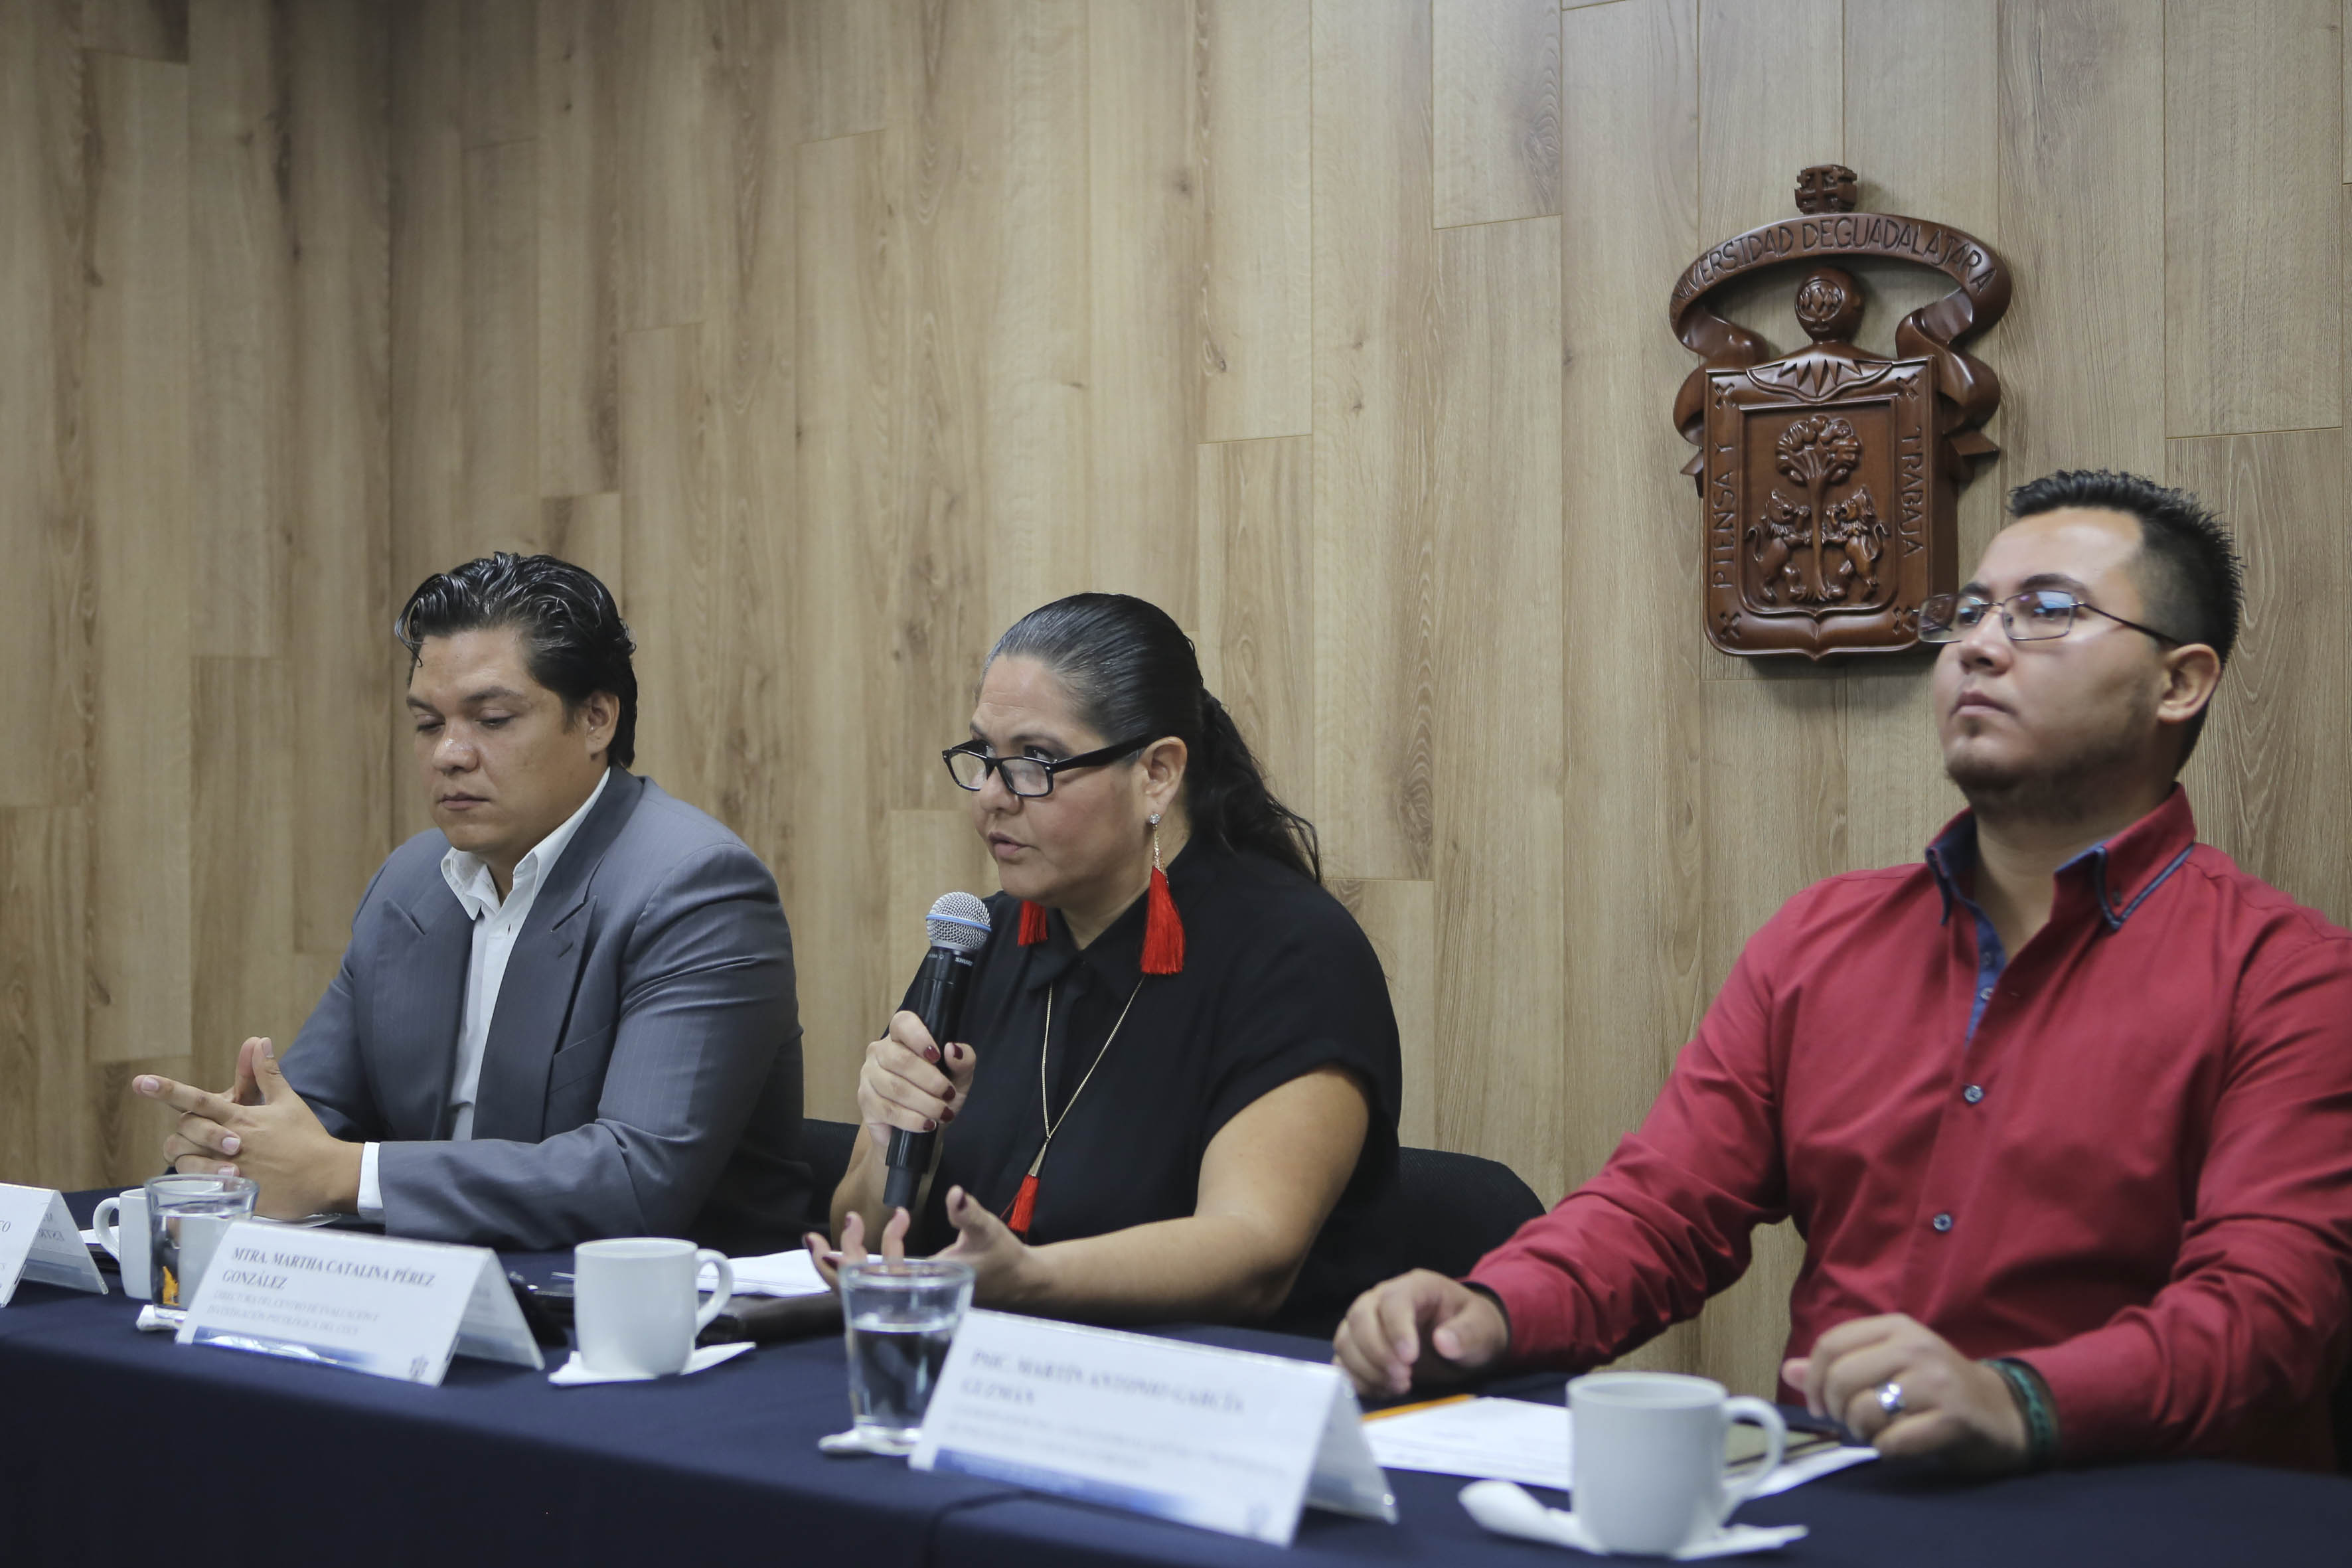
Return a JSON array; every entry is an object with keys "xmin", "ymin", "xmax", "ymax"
[{"xmin": 809, "ymin": 592, "xmax": 1402, "ymax": 1326}]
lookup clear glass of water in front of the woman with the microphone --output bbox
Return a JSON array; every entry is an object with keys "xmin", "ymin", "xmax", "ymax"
[{"xmin": 842, "ymin": 1258, "xmax": 971, "ymax": 1452}]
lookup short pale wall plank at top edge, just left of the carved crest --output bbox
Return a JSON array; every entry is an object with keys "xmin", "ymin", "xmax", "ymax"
[{"xmin": 1430, "ymin": 0, "xmax": 1559, "ymax": 228}]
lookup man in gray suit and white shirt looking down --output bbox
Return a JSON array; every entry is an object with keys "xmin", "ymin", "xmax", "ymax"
[{"xmin": 134, "ymin": 552, "xmax": 811, "ymax": 1253}]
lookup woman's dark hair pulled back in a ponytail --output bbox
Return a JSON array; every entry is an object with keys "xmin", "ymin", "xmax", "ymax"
[{"xmin": 988, "ymin": 592, "xmax": 1322, "ymax": 882}]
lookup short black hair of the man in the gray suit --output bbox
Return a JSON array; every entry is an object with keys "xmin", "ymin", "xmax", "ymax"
[{"xmin": 393, "ymin": 550, "xmax": 637, "ymax": 769}]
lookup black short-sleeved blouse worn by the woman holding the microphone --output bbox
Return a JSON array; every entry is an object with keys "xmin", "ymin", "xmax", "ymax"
[{"xmin": 919, "ymin": 839, "xmax": 1404, "ymax": 1324}]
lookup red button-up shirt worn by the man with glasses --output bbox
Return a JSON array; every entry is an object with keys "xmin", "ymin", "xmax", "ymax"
[{"xmin": 1470, "ymin": 790, "xmax": 2352, "ymax": 1467}]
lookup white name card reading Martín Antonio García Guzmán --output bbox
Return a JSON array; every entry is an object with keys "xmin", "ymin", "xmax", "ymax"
[{"xmin": 908, "ymin": 1312, "xmax": 1397, "ymax": 1547}]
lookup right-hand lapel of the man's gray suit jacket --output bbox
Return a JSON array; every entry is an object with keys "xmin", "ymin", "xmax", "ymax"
[{"xmin": 473, "ymin": 771, "xmax": 645, "ymax": 1142}]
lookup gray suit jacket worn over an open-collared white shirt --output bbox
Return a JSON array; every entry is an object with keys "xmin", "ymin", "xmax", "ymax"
[{"xmin": 285, "ymin": 769, "xmax": 811, "ymax": 1253}]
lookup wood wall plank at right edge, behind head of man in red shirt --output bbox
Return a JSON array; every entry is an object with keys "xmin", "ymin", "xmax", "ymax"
[{"xmin": 2169, "ymin": 430, "xmax": 2352, "ymax": 924}]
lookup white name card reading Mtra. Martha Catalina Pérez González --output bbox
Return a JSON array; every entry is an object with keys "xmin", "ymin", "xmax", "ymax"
[{"xmin": 179, "ymin": 1220, "xmax": 546, "ymax": 1385}]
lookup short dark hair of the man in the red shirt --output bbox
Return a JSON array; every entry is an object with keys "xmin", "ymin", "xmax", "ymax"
[{"xmin": 2009, "ymin": 468, "xmax": 2246, "ymax": 761}]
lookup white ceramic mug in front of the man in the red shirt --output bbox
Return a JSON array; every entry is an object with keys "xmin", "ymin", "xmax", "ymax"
[{"xmin": 1569, "ymin": 1373, "xmax": 1788, "ymax": 1556}]
